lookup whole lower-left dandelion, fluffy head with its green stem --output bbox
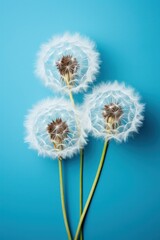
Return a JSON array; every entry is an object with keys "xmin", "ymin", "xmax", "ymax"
[{"xmin": 25, "ymin": 99, "xmax": 86, "ymax": 240}]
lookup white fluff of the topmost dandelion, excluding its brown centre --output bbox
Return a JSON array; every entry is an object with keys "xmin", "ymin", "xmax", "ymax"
[{"xmin": 35, "ymin": 33, "xmax": 100, "ymax": 92}]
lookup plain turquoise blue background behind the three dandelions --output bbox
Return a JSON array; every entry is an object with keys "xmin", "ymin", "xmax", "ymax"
[{"xmin": 0, "ymin": 0, "xmax": 160, "ymax": 240}]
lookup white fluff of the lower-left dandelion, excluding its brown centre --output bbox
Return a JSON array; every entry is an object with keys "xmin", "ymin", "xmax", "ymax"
[{"xmin": 25, "ymin": 98, "xmax": 86, "ymax": 159}]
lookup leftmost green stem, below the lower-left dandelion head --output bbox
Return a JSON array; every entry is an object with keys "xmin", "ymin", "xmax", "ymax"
[{"xmin": 58, "ymin": 157, "xmax": 72, "ymax": 240}]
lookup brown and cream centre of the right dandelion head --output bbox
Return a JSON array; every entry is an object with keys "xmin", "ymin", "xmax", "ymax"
[{"xmin": 102, "ymin": 103, "xmax": 123, "ymax": 133}]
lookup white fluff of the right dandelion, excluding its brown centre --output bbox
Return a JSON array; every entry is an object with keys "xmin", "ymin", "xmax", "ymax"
[{"xmin": 83, "ymin": 81, "xmax": 144, "ymax": 142}]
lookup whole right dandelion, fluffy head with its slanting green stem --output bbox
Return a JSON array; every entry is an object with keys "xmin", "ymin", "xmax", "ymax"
[{"xmin": 74, "ymin": 82, "xmax": 144, "ymax": 240}]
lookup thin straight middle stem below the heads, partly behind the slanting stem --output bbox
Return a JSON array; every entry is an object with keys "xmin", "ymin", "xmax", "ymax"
[{"xmin": 79, "ymin": 149, "xmax": 84, "ymax": 240}]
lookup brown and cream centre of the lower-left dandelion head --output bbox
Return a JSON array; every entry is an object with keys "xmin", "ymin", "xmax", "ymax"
[{"xmin": 47, "ymin": 118, "xmax": 69, "ymax": 150}]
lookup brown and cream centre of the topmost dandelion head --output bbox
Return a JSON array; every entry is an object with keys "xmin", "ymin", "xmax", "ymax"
[{"xmin": 56, "ymin": 55, "xmax": 79, "ymax": 86}]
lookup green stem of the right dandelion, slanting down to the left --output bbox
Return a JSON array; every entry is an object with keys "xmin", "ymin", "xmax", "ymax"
[{"xmin": 74, "ymin": 141, "xmax": 108, "ymax": 240}]
